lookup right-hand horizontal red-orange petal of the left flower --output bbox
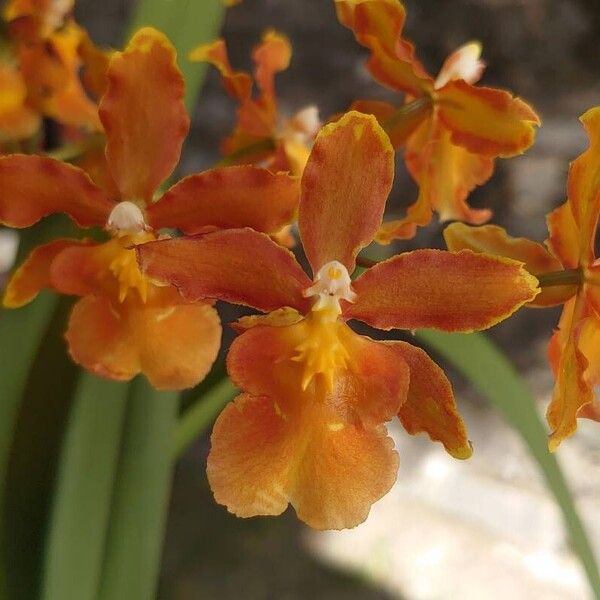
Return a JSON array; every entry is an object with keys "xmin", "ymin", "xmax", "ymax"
[{"xmin": 146, "ymin": 166, "xmax": 300, "ymax": 234}]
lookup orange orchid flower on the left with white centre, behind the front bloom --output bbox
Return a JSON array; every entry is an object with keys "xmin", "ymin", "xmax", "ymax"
[{"xmin": 0, "ymin": 28, "xmax": 299, "ymax": 389}]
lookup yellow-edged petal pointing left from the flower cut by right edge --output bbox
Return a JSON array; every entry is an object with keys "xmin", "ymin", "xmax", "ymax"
[{"xmin": 444, "ymin": 223, "xmax": 577, "ymax": 307}]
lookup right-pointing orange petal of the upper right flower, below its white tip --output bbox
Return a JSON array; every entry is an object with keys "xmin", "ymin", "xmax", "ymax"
[{"xmin": 437, "ymin": 80, "xmax": 540, "ymax": 157}]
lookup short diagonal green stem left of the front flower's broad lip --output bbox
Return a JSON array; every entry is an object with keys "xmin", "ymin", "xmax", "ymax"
[{"xmin": 173, "ymin": 378, "xmax": 238, "ymax": 459}]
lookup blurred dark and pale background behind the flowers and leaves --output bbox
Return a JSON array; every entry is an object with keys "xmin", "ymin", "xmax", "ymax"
[{"xmin": 23, "ymin": 0, "xmax": 600, "ymax": 600}]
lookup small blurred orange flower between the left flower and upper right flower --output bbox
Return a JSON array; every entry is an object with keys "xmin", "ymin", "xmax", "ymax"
[{"xmin": 189, "ymin": 31, "xmax": 321, "ymax": 175}]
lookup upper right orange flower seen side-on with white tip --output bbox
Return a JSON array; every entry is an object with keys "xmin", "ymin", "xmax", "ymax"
[{"xmin": 335, "ymin": 0, "xmax": 540, "ymax": 244}]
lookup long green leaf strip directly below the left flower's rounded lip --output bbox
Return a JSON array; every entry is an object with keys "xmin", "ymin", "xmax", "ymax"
[{"xmin": 97, "ymin": 378, "xmax": 178, "ymax": 600}]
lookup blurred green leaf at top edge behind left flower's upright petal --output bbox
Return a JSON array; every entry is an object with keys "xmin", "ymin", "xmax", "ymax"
[{"xmin": 130, "ymin": 0, "xmax": 224, "ymax": 111}]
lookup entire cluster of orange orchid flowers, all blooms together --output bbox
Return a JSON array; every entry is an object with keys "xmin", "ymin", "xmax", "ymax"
[{"xmin": 0, "ymin": 0, "xmax": 600, "ymax": 529}]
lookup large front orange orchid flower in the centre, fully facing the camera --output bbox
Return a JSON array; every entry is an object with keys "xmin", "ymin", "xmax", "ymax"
[{"xmin": 137, "ymin": 112, "xmax": 537, "ymax": 529}]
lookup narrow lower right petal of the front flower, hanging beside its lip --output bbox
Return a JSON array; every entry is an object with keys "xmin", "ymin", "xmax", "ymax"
[{"xmin": 389, "ymin": 342, "xmax": 473, "ymax": 459}]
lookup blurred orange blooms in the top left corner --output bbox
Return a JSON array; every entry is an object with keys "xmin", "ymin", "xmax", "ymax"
[{"xmin": 0, "ymin": 0, "xmax": 108, "ymax": 150}]
